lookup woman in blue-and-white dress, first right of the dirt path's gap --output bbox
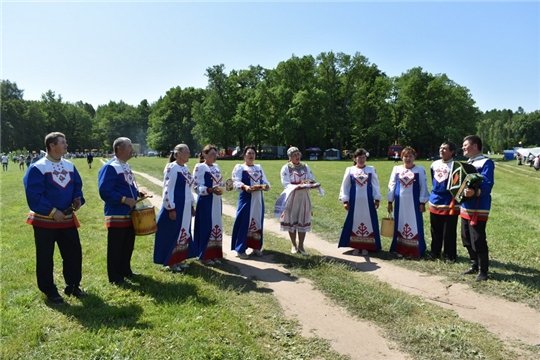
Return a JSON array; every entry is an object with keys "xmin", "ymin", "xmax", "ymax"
[{"xmin": 338, "ymin": 148, "xmax": 381, "ymax": 256}]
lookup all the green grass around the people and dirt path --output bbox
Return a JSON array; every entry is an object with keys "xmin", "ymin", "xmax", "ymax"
[{"xmin": 1, "ymin": 158, "xmax": 540, "ymax": 359}]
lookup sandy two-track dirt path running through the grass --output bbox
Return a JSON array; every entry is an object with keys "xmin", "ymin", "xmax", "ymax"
[{"xmin": 134, "ymin": 171, "xmax": 540, "ymax": 359}]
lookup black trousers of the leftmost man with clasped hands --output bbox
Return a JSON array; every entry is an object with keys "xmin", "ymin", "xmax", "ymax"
[{"xmin": 34, "ymin": 226, "xmax": 82, "ymax": 294}]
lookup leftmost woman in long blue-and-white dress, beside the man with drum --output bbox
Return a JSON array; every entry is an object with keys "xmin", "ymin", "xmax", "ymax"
[{"xmin": 154, "ymin": 144, "xmax": 195, "ymax": 272}]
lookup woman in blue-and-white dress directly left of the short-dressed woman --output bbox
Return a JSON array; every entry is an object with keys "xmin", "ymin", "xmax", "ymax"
[{"xmin": 231, "ymin": 145, "xmax": 270, "ymax": 259}]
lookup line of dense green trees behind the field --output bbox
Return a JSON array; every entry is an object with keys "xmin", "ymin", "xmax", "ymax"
[{"xmin": 0, "ymin": 52, "xmax": 540, "ymax": 156}]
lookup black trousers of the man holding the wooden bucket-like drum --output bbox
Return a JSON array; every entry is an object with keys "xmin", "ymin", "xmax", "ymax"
[{"xmin": 107, "ymin": 226, "xmax": 135, "ymax": 282}]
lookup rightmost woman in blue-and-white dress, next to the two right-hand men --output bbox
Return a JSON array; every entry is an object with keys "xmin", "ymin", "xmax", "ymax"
[{"xmin": 386, "ymin": 146, "xmax": 429, "ymax": 258}]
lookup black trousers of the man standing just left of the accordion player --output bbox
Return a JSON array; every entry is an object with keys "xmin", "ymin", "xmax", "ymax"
[{"xmin": 429, "ymin": 213, "xmax": 459, "ymax": 260}]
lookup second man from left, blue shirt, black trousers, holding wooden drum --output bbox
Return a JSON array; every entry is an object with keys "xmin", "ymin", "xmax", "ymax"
[{"xmin": 98, "ymin": 137, "xmax": 144, "ymax": 285}]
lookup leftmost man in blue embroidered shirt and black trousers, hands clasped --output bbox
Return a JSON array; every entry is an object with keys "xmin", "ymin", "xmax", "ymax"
[{"xmin": 23, "ymin": 132, "xmax": 86, "ymax": 304}]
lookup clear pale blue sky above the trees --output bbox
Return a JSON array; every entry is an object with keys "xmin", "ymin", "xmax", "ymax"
[{"xmin": 0, "ymin": 0, "xmax": 540, "ymax": 112}]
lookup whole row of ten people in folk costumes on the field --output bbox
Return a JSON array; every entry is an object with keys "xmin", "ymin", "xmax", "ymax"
[{"xmin": 23, "ymin": 132, "xmax": 494, "ymax": 303}]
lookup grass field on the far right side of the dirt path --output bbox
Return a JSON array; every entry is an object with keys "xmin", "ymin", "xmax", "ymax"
[{"xmin": 130, "ymin": 158, "xmax": 540, "ymax": 310}]
